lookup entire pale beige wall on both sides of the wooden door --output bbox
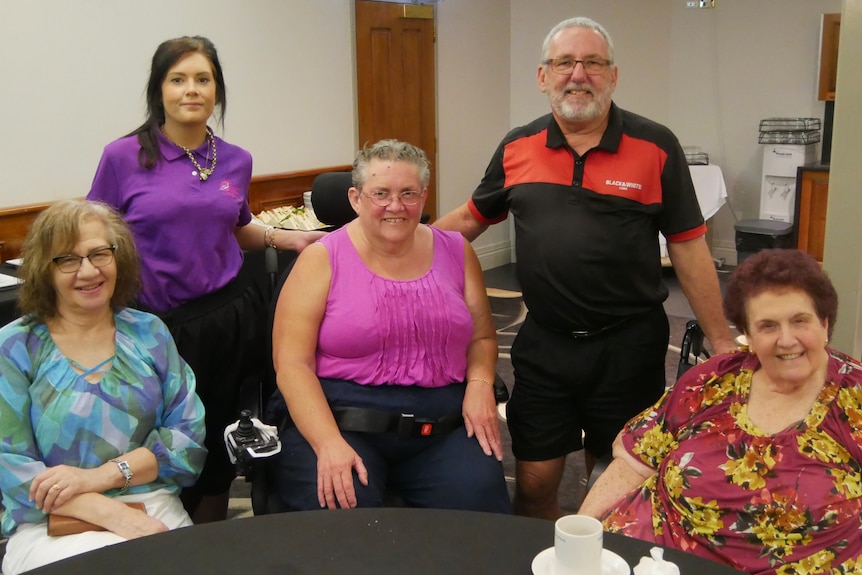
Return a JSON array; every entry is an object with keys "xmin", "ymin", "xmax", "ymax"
[{"xmin": 0, "ymin": 0, "xmax": 852, "ymax": 267}]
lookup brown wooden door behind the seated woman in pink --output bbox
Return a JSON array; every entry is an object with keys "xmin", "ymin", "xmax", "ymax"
[{"xmin": 356, "ymin": 0, "xmax": 437, "ymax": 221}]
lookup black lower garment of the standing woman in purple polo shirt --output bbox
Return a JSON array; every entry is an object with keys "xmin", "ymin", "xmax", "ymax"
[{"xmin": 154, "ymin": 271, "xmax": 267, "ymax": 500}]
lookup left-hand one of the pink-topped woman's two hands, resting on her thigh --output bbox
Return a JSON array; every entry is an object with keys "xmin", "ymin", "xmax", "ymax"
[{"xmin": 317, "ymin": 437, "xmax": 368, "ymax": 509}]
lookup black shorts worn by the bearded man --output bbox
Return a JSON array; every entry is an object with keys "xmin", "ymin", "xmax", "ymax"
[{"xmin": 506, "ymin": 306, "xmax": 669, "ymax": 461}]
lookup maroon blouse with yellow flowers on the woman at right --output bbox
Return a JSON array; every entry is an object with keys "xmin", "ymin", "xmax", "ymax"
[{"xmin": 604, "ymin": 350, "xmax": 862, "ymax": 575}]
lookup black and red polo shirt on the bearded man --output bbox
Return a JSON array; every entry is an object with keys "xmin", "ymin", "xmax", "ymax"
[{"xmin": 469, "ymin": 104, "xmax": 706, "ymax": 331}]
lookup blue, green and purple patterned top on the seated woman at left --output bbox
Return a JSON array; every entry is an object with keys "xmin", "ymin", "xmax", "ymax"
[{"xmin": 0, "ymin": 308, "xmax": 206, "ymax": 535}]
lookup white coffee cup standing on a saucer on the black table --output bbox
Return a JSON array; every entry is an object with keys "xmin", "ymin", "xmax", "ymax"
[{"xmin": 554, "ymin": 515, "xmax": 604, "ymax": 575}]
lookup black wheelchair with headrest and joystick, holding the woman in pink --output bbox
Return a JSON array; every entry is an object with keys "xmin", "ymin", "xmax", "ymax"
[{"xmin": 230, "ymin": 172, "xmax": 509, "ymax": 515}]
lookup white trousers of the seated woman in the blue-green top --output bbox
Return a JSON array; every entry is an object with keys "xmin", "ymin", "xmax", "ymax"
[{"xmin": 3, "ymin": 489, "xmax": 192, "ymax": 575}]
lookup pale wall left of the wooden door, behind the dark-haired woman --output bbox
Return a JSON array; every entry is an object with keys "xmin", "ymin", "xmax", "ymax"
[{"xmin": 0, "ymin": 0, "xmax": 356, "ymax": 207}]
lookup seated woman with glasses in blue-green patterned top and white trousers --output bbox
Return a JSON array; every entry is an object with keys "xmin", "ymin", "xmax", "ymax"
[{"xmin": 0, "ymin": 200, "xmax": 206, "ymax": 575}]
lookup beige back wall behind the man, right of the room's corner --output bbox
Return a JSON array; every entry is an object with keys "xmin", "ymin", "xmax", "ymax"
[{"xmin": 506, "ymin": 0, "xmax": 841, "ymax": 263}]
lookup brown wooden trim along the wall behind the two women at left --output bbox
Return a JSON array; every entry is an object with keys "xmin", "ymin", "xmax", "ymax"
[{"xmin": 0, "ymin": 164, "xmax": 352, "ymax": 262}]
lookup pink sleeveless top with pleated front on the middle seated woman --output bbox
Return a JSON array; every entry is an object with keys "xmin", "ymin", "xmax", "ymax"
[{"xmin": 317, "ymin": 227, "xmax": 473, "ymax": 387}]
